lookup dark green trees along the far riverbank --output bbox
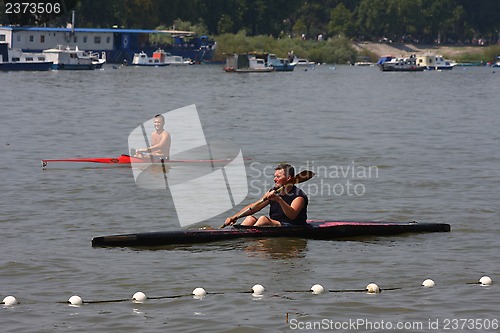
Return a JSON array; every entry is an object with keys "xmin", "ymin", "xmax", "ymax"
[{"xmin": 0, "ymin": 0, "xmax": 500, "ymax": 44}]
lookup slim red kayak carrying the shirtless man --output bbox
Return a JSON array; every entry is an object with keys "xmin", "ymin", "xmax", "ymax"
[{"xmin": 41, "ymin": 154, "xmax": 240, "ymax": 169}]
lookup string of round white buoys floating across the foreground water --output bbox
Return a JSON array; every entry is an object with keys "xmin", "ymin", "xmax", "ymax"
[{"xmin": 0, "ymin": 276, "xmax": 493, "ymax": 307}]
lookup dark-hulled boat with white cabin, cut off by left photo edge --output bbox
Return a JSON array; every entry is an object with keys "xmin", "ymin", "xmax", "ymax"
[{"xmin": 0, "ymin": 43, "xmax": 52, "ymax": 71}]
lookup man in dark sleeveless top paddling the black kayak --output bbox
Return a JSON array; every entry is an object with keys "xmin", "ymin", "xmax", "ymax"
[{"xmin": 224, "ymin": 163, "xmax": 309, "ymax": 227}]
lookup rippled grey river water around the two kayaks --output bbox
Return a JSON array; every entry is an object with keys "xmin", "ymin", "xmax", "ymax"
[{"xmin": 0, "ymin": 65, "xmax": 500, "ymax": 332}]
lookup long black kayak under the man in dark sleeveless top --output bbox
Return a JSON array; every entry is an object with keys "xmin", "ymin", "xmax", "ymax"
[{"xmin": 92, "ymin": 221, "xmax": 451, "ymax": 247}]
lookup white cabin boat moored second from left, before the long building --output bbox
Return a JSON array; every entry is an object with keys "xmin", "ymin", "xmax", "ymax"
[{"xmin": 43, "ymin": 45, "xmax": 97, "ymax": 70}]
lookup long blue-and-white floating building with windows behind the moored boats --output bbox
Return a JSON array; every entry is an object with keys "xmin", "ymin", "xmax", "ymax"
[{"xmin": 0, "ymin": 26, "xmax": 216, "ymax": 63}]
